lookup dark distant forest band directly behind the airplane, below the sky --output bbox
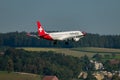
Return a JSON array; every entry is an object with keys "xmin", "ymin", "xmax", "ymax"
[{"xmin": 0, "ymin": 32, "xmax": 120, "ymax": 48}]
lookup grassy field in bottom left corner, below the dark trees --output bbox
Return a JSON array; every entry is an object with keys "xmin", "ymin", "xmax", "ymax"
[{"xmin": 0, "ymin": 71, "xmax": 42, "ymax": 80}]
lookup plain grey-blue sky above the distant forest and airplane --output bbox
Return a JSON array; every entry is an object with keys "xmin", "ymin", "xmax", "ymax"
[{"xmin": 0, "ymin": 0, "xmax": 120, "ymax": 35}]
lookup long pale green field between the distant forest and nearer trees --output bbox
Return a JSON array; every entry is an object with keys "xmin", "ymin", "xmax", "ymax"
[{"xmin": 18, "ymin": 47, "xmax": 120, "ymax": 59}]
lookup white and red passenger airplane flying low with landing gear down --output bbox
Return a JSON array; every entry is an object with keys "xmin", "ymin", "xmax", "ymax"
[{"xmin": 27, "ymin": 21, "xmax": 86, "ymax": 44}]
